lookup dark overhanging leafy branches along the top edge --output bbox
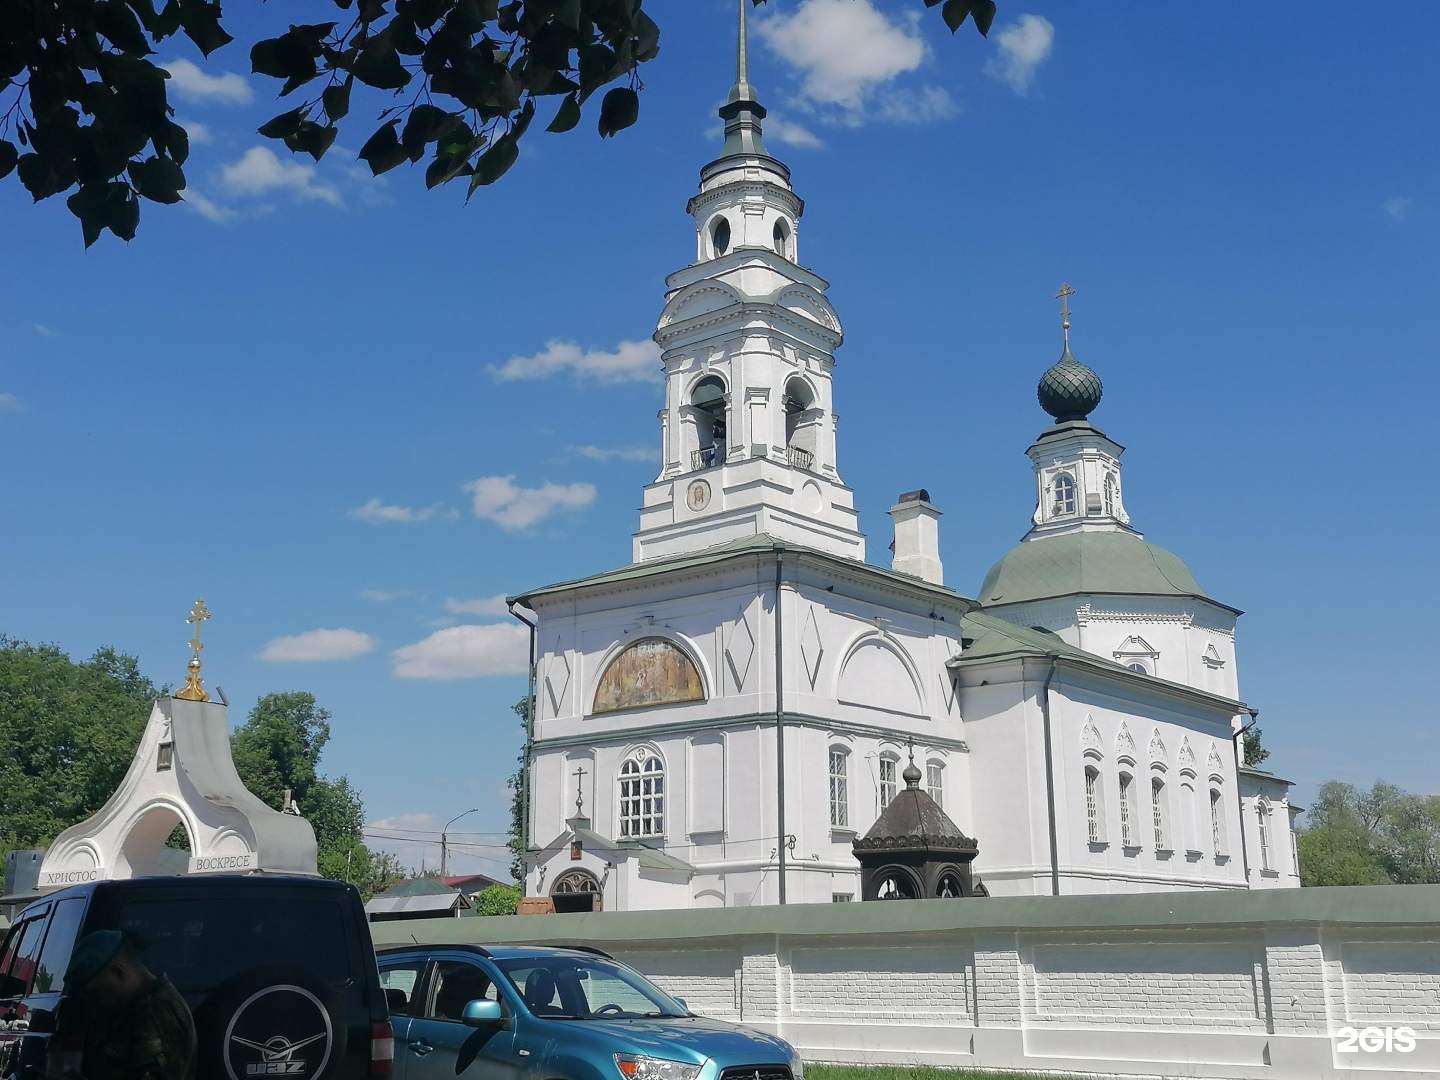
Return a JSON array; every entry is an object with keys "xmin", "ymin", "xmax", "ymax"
[{"xmin": 0, "ymin": 0, "xmax": 995, "ymax": 246}]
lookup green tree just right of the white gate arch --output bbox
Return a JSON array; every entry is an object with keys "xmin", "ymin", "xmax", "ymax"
[{"xmin": 230, "ymin": 691, "xmax": 403, "ymax": 894}]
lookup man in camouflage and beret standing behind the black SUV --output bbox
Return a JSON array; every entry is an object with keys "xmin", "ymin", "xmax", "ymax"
[{"xmin": 65, "ymin": 930, "xmax": 196, "ymax": 1080}]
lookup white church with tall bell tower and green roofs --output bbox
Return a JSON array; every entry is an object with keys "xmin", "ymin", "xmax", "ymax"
[{"xmin": 514, "ymin": 3, "xmax": 1299, "ymax": 910}]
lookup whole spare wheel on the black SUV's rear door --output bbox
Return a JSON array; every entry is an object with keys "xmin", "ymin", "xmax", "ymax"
[{"xmin": 194, "ymin": 966, "xmax": 348, "ymax": 1080}]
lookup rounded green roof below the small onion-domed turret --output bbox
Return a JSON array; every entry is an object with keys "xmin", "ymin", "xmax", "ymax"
[{"xmin": 976, "ymin": 533, "xmax": 1234, "ymax": 611}]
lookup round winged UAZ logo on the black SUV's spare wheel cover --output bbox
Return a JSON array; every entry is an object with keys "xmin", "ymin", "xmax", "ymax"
[{"xmin": 225, "ymin": 984, "xmax": 334, "ymax": 1080}]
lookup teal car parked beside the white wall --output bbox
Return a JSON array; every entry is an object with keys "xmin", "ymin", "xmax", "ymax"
[{"xmin": 377, "ymin": 945, "xmax": 804, "ymax": 1080}]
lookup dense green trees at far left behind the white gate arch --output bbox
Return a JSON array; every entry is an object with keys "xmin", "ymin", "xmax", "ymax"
[{"xmin": 0, "ymin": 635, "xmax": 160, "ymax": 854}]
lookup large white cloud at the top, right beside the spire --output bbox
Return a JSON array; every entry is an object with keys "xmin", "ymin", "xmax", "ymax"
[{"xmin": 756, "ymin": 0, "xmax": 926, "ymax": 114}]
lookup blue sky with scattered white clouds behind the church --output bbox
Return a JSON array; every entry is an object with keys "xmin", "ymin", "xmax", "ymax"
[{"xmin": 0, "ymin": 0, "xmax": 1440, "ymax": 868}]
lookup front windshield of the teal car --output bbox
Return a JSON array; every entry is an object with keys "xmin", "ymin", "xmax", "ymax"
[{"xmin": 497, "ymin": 956, "xmax": 690, "ymax": 1020}]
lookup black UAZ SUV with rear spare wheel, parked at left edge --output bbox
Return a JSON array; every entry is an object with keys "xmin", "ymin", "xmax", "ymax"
[{"xmin": 0, "ymin": 876, "xmax": 395, "ymax": 1080}]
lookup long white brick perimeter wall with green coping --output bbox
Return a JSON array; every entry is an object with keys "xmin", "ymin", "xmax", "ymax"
[{"xmin": 372, "ymin": 886, "xmax": 1440, "ymax": 1080}]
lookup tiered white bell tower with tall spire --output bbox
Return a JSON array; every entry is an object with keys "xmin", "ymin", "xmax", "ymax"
[{"xmin": 634, "ymin": 0, "xmax": 865, "ymax": 562}]
